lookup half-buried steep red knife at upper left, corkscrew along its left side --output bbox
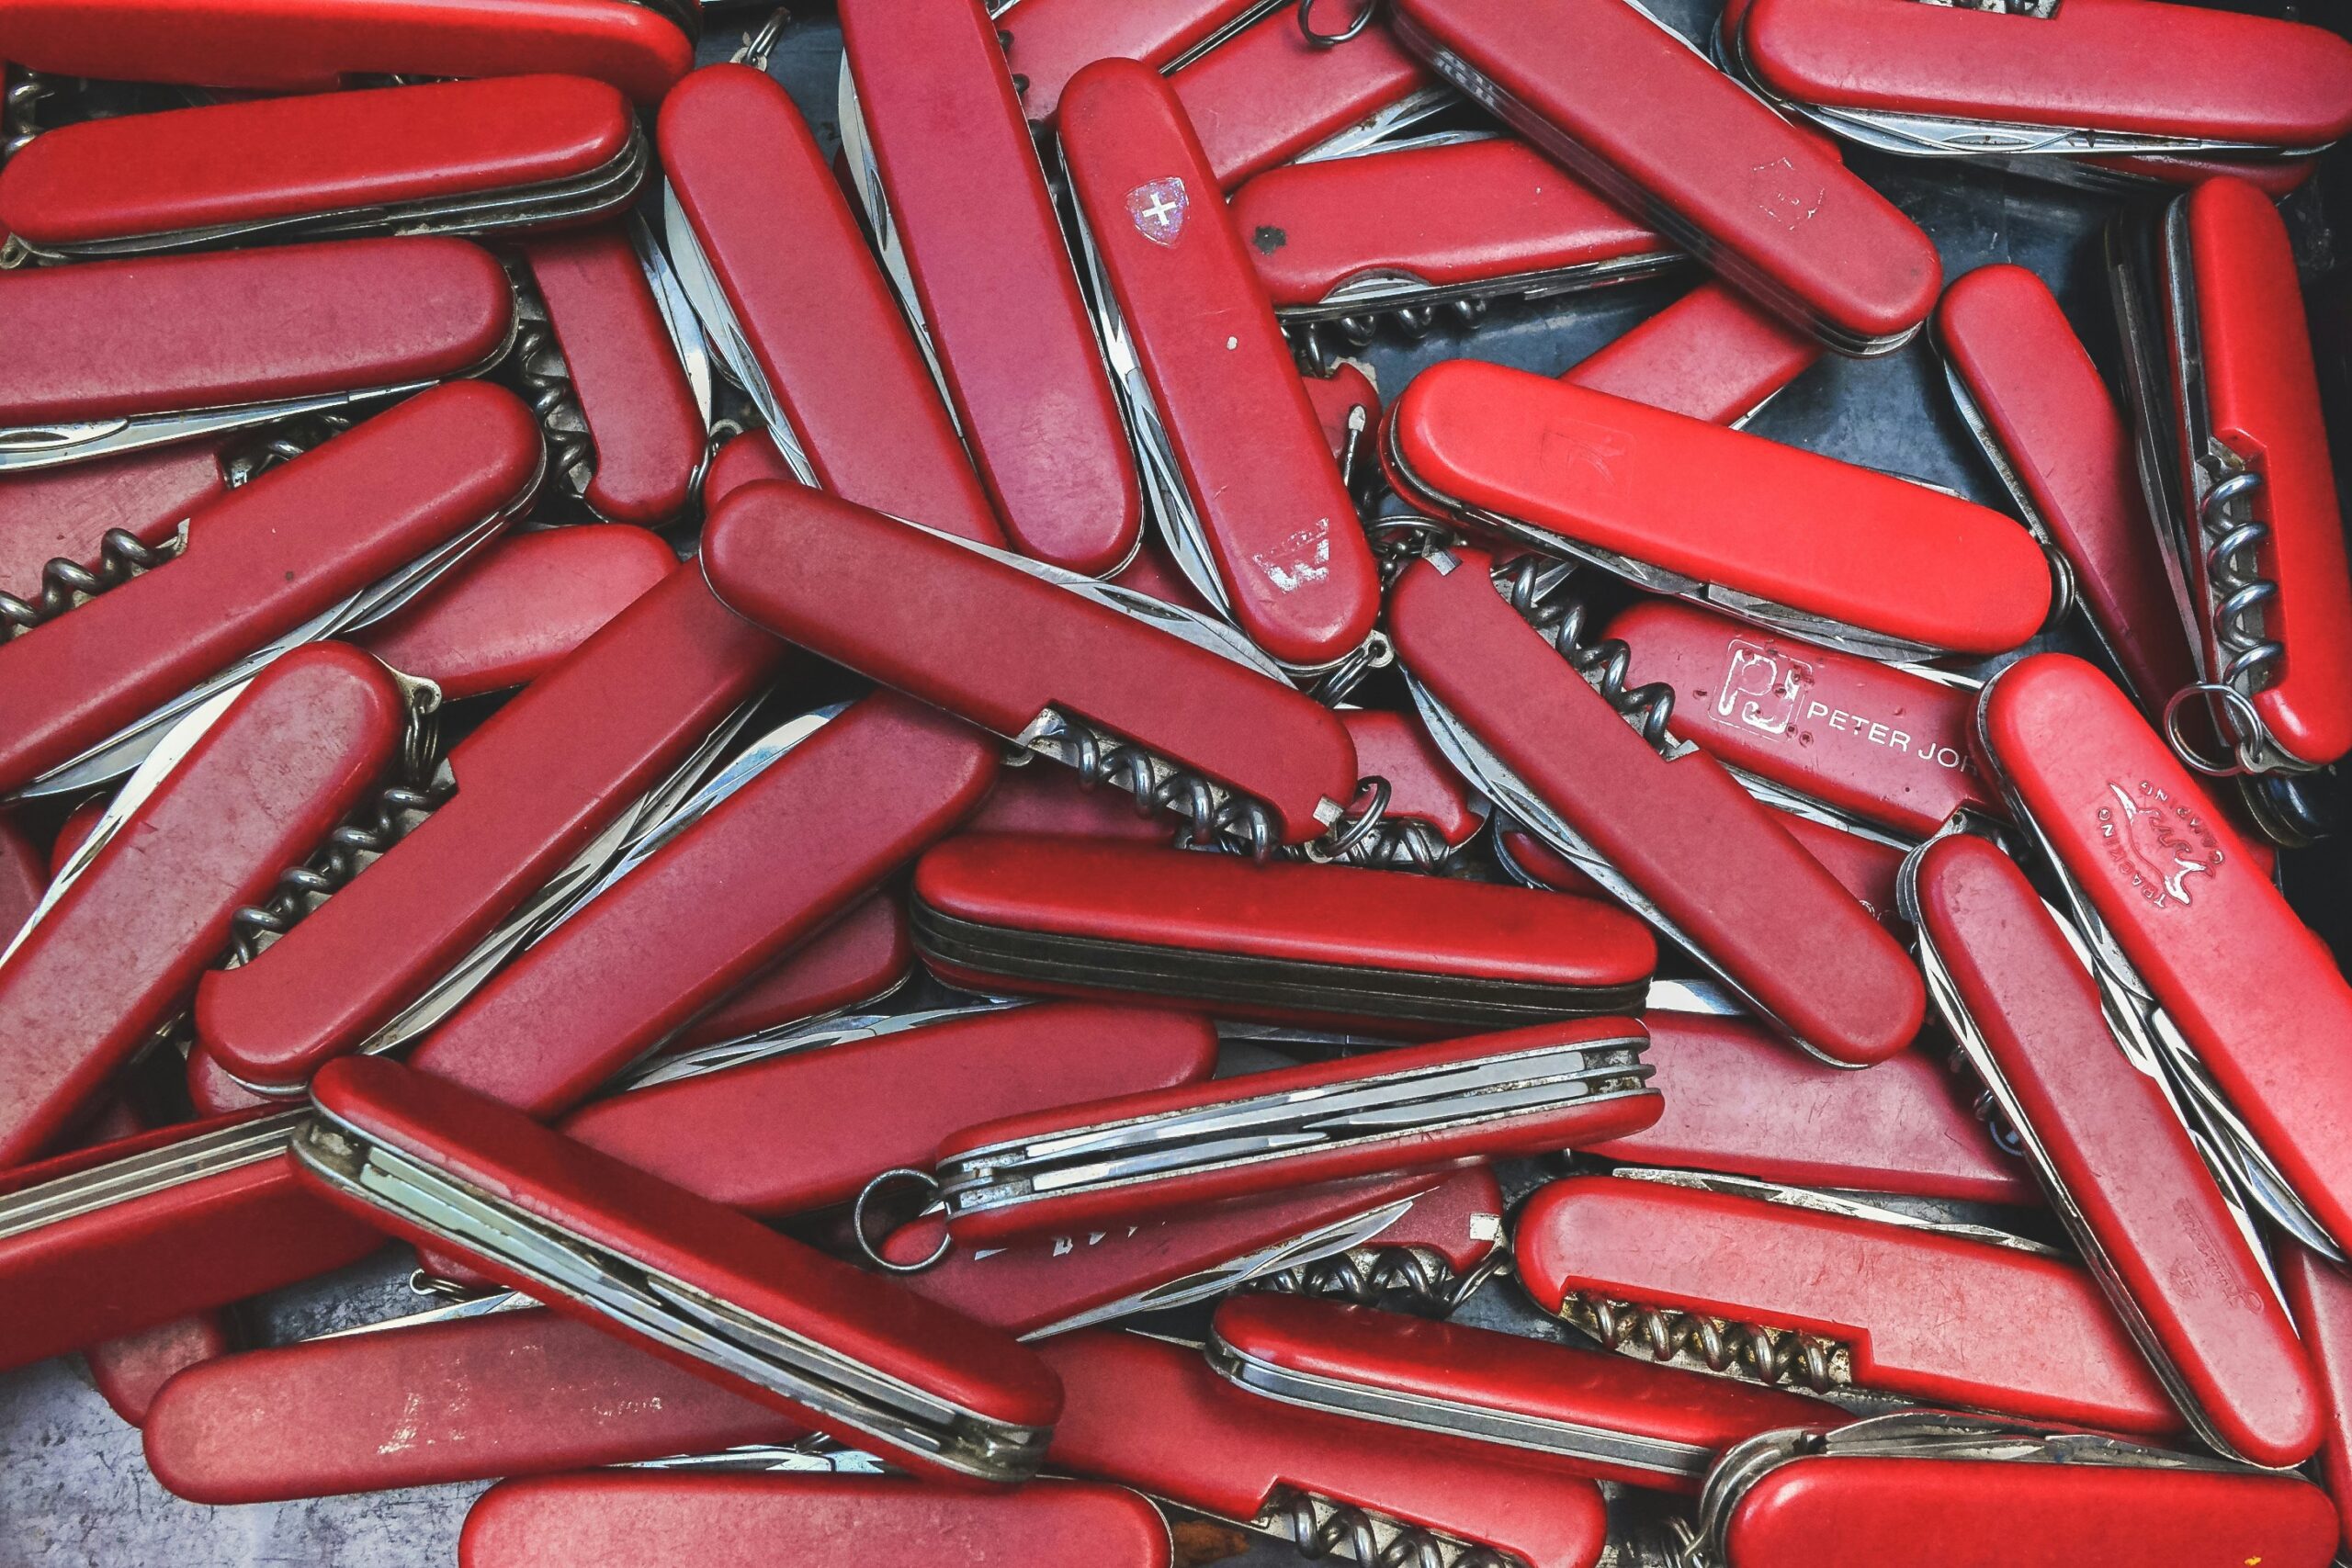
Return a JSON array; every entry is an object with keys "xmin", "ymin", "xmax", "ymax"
[{"xmin": 515, "ymin": 219, "xmax": 710, "ymax": 529}]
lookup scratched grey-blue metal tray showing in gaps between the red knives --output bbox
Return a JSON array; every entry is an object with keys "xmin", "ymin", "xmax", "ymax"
[{"xmin": 0, "ymin": 0, "xmax": 2352, "ymax": 1568}]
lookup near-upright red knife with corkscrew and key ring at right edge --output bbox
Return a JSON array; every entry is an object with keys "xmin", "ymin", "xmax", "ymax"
[{"xmin": 2109, "ymin": 177, "xmax": 2352, "ymax": 841}]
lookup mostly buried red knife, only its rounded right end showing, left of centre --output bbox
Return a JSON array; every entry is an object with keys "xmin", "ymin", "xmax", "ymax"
[{"xmin": 356, "ymin": 525, "xmax": 677, "ymax": 703}]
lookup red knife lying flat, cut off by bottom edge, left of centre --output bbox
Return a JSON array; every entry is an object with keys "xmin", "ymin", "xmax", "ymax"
[{"xmin": 457, "ymin": 1474, "xmax": 1171, "ymax": 1568}]
